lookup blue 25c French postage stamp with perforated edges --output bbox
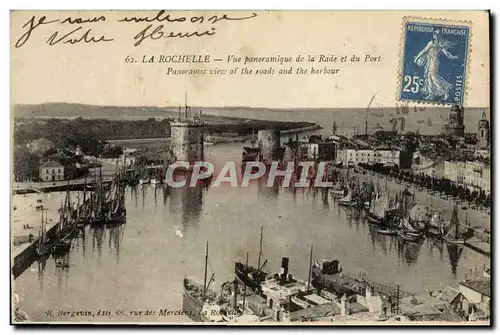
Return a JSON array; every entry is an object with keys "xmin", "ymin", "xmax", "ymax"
[{"xmin": 398, "ymin": 18, "xmax": 471, "ymax": 105}]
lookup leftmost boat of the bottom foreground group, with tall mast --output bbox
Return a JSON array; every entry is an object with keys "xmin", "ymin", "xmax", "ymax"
[{"xmin": 183, "ymin": 241, "xmax": 217, "ymax": 321}]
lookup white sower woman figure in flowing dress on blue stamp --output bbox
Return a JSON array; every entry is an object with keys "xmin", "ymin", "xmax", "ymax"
[{"xmin": 414, "ymin": 30, "xmax": 458, "ymax": 100}]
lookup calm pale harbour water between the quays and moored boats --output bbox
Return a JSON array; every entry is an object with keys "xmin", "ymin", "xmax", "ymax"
[{"xmin": 13, "ymin": 144, "xmax": 489, "ymax": 323}]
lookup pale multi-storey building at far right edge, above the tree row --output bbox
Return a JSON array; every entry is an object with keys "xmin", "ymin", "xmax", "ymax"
[{"xmin": 444, "ymin": 161, "xmax": 491, "ymax": 193}]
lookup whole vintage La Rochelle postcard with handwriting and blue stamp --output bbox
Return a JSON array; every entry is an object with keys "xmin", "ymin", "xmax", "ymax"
[{"xmin": 10, "ymin": 10, "xmax": 492, "ymax": 326}]
